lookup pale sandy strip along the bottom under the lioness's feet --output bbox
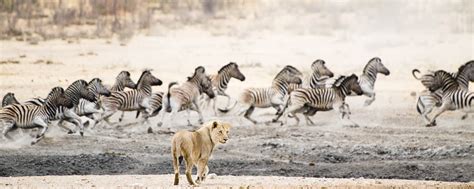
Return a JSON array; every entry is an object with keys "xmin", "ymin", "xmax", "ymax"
[{"xmin": 0, "ymin": 175, "xmax": 474, "ymax": 189}]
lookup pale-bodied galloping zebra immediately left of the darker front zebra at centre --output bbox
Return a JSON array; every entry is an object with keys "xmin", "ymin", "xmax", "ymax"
[{"xmin": 219, "ymin": 65, "xmax": 302, "ymax": 124}]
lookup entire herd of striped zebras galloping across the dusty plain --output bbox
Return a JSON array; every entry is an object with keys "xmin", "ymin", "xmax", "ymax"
[{"xmin": 0, "ymin": 57, "xmax": 474, "ymax": 144}]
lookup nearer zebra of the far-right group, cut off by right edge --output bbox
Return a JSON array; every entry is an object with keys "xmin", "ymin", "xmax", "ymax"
[{"xmin": 426, "ymin": 68, "xmax": 474, "ymax": 127}]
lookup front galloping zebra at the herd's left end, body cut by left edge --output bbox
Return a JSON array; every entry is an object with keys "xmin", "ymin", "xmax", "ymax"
[{"xmin": 0, "ymin": 87, "xmax": 74, "ymax": 145}]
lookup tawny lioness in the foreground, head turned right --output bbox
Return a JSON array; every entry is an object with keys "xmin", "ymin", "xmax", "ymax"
[{"xmin": 171, "ymin": 121, "xmax": 231, "ymax": 185}]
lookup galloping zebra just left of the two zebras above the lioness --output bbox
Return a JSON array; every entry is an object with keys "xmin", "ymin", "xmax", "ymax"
[{"xmin": 101, "ymin": 70, "xmax": 163, "ymax": 124}]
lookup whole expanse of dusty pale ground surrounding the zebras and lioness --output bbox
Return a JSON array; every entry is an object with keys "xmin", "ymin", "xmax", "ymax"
[{"xmin": 0, "ymin": 29, "xmax": 474, "ymax": 186}]
